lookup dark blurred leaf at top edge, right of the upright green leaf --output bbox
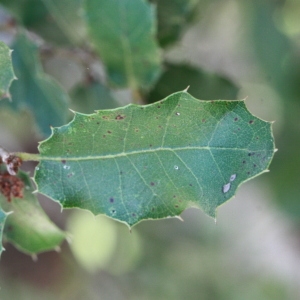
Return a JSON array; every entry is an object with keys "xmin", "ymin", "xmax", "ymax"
[{"xmin": 152, "ymin": 0, "xmax": 199, "ymax": 47}]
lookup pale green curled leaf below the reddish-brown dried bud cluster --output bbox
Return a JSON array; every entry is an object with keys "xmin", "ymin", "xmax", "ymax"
[{"xmin": 0, "ymin": 172, "xmax": 66, "ymax": 254}]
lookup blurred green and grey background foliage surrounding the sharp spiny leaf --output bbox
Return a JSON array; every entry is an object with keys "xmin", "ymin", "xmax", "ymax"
[{"xmin": 0, "ymin": 0, "xmax": 300, "ymax": 300}]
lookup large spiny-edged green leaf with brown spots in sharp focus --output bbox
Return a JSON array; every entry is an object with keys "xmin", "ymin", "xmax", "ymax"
[{"xmin": 35, "ymin": 91, "xmax": 274, "ymax": 226}]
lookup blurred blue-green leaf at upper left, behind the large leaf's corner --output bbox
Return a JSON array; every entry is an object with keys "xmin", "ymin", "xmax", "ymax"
[{"xmin": 1, "ymin": 34, "xmax": 69, "ymax": 135}]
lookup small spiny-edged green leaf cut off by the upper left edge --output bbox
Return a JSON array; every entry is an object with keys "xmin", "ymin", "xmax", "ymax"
[{"xmin": 0, "ymin": 42, "xmax": 16, "ymax": 100}]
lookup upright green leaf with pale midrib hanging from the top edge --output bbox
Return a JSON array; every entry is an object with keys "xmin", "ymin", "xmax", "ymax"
[{"xmin": 85, "ymin": 0, "xmax": 160, "ymax": 90}]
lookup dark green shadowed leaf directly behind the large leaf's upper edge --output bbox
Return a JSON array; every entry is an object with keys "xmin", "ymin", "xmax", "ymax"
[{"xmin": 147, "ymin": 64, "xmax": 238, "ymax": 103}]
